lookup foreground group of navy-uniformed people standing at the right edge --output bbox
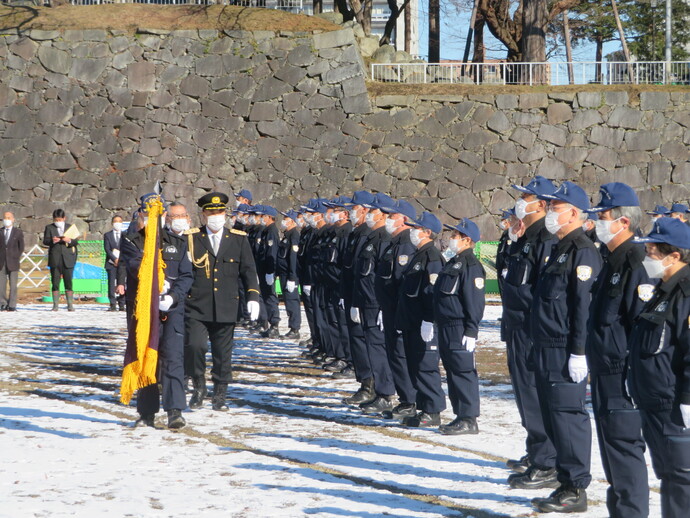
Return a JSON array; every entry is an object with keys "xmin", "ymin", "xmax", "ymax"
[{"xmin": 497, "ymin": 177, "xmax": 690, "ymax": 518}]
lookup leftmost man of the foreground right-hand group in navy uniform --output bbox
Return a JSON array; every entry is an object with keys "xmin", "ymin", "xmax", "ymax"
[{"xmin": 501, "ymin": 176, "xmax": 558, "ymax": 489}]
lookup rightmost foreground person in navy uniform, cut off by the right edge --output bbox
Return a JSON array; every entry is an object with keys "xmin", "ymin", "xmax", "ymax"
[{"xmin": 628, "ymin": 218, "xmax": 690, "ymax": 518}]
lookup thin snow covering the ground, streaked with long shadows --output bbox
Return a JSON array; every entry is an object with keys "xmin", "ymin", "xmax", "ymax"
[{"xmin": 0, "ymin": 304, "xmax": 660, "ymax": 518}]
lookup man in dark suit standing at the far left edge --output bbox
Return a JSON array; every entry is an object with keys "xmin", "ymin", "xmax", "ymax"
[{"xmin": 0, "ymin": 211, "xmax": 24, "ymax": 311}]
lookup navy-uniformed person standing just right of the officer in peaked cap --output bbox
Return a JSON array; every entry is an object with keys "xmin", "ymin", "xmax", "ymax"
[{"xmin": 256, "ymin": 205, "xmax": 280, "ymax": 338}]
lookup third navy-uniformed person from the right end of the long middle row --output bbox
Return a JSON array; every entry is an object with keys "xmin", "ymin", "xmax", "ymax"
[{"xmin": 376, "ymin": 200, "xmax": 417, "ymax": 419}]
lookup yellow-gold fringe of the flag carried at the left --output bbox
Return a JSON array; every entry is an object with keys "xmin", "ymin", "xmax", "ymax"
[{"xmin": 120, "ymin": 198, "xmax": 165, "ymax": 405}]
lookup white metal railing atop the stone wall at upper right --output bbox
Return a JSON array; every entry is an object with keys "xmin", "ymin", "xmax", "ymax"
[{"xmin": 371, "ymin": 61, "xmax": 690, "ymax": 85}]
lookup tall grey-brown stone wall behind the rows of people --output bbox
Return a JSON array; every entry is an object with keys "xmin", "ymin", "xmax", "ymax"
[{"xmin": 0, "ymin": 29, "xmax": 690, "ymax": 246}]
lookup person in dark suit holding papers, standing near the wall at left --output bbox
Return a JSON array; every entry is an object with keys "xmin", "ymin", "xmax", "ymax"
[{"xmin": 43, "ymin": 209, "xmax": 79, "ymax": 311}]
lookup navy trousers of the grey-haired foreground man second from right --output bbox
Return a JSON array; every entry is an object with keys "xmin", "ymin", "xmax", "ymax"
[{"xmin": 592, "ymin": 374, "xmax": 649, "ymax": 518}]
